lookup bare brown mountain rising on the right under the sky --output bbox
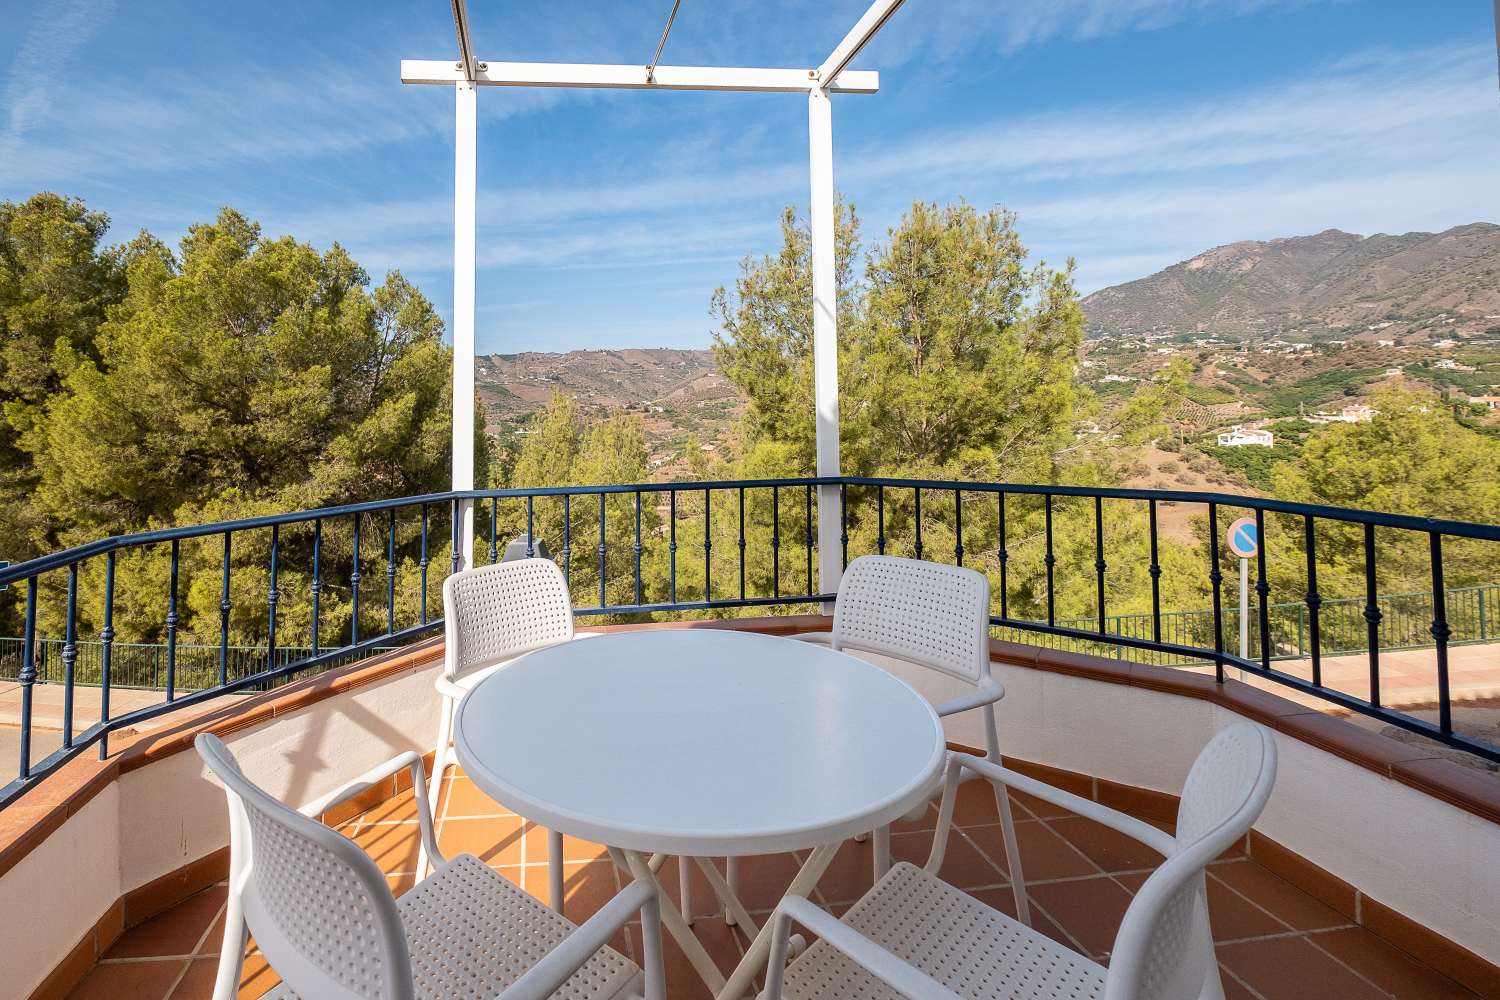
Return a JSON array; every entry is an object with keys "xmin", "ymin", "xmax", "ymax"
[{"xmin": 1083, "ymin": 222, "xmax": 1500, "ymax": 337}]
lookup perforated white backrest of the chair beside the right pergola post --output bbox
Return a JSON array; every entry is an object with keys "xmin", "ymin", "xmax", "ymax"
[{"xmin": 833, "ymin": 556, "xmax": 990, "ymax": 684}]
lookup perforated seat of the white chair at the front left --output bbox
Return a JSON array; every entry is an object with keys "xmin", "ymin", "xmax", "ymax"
[{"xmin": 269, "ymin": 855, "xmax": 641, "ymax": 1000}]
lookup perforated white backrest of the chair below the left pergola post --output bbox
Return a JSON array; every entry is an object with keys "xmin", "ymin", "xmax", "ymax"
[{"xmin": 443, "ymin": 559, "xmax": 573, "ymax": 679}]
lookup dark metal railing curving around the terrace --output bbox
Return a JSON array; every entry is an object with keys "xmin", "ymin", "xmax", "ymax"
[{"xmin": 0, "ymin": 477, "xmax": 1500, "ymax": 804}]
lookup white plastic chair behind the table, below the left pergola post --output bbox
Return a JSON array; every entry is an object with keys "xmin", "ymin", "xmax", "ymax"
[{"xmin": 417, "ymin": 559, "xmax": 573, "ymax": 913}]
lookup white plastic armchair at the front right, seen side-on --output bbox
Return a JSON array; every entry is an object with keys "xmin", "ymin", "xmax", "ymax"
[{"xmin": 764, "ymin": 723, "xmax": 1277, "ymax": 1000}]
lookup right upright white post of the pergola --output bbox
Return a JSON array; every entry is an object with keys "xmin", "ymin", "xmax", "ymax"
[{"xmin": 807, "ymin": 87, "xmax": 843, "ymax": 613}]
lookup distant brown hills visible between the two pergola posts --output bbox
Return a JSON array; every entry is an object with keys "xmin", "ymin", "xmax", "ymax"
[{"xmin": 474, "ymin": 348, "xmax": 741, "ymax": 448}]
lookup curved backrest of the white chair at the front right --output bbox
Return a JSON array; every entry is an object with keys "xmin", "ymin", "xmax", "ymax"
[{"xmin": 1104, "ymin": 723, "xmax": 1277, "ymax": 1000}]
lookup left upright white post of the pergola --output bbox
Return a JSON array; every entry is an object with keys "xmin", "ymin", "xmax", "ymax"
[{"xmin": 453, "ymin": 81, "xmax": 479, "ymax": 570}]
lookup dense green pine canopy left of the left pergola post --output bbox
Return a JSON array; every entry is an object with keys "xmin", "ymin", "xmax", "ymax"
[{"xmin": 0, "ymin": 193, "xmax": 474, "ymax": 639}]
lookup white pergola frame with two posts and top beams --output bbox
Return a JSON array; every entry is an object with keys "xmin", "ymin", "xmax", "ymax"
[{"xmin": 401, "ymin": 0, "xmax": 903, "ymax": 594}]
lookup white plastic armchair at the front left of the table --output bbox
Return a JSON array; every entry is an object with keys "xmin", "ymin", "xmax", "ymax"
[{"xmin": 195, "ymin": 733, "xmax": 666, "ymax": 1000}]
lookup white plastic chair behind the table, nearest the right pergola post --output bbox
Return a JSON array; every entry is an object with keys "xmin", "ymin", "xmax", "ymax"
[{"xmin": 798, "ymin": 556, "xmax": 1031, "ymax": 925}]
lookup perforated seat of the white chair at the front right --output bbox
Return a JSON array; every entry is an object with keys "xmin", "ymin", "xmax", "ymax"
[{"xmin": 785, "ymin": 862, "xmax": 1104, "ymax": 1000}]
